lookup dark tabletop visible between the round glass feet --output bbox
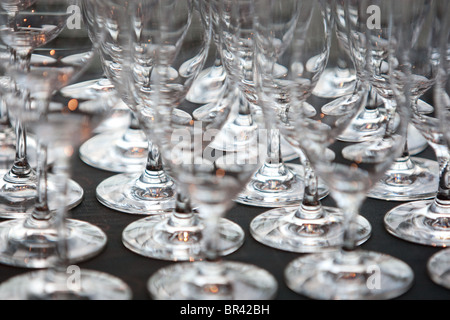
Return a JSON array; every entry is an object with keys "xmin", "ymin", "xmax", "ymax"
[{"xmin": 0, "ymin": 139, "xmax": 450, "ymax": 300}]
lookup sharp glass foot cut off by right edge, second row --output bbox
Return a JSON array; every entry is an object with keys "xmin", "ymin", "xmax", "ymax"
[{"xmin": 384, "ymin": 199, "xmax": 450, "ymax": 247}]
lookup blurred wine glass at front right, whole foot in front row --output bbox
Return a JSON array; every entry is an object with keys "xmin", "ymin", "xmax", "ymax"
[{"xmin": 285, "ymin": 0, "xmax": 417, "ymax": 299}]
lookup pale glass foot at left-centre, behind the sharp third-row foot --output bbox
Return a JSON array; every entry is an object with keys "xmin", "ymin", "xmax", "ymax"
[{"xmin": 80, "ymin": 130, "xmax": 148, "ymax": 173}]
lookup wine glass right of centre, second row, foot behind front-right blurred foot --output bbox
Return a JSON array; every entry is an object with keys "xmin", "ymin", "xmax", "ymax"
[{"xmin": 250, "ymin": 1, "xmax": 371, "ymax": 252}]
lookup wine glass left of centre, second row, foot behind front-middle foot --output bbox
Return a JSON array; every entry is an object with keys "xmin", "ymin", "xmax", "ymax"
[{"xmin": 99, "ymin": 1, "xmax": 244, "ymax": 261}]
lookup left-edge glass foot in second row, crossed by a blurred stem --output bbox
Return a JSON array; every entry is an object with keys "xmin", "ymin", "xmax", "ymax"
[{"xmin": 0, "ymin": 219, "xmax": 107, "ymax": 269}]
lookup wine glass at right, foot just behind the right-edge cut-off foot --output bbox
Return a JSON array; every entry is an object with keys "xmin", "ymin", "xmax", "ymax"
[{"xmin": 335, "ymin": 1, "xmax": 439, "ymax": 201}]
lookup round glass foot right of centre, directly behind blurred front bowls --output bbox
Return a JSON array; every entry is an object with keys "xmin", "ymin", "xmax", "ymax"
[{"xmin": 235, "ymin": 164, "xmax": 329, "ymax": 208}]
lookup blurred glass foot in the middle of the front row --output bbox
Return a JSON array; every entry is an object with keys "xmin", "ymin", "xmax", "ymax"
[{"xmin": 147, "ymin": 261, "xmax": 278, "ymax": 300}]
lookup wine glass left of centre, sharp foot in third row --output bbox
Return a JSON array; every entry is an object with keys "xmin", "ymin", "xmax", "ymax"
[{"xmin": 95, "ymin": 1, "xmax": 183, "ymax": 215}]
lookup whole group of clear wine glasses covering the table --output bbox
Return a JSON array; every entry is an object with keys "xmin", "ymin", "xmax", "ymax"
[{"xmin": 0, "ymin": 0, "xmax": 450, "ymax": 299}]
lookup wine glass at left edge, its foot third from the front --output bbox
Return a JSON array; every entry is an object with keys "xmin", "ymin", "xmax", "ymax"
[{"xmin": 0, "ymin": 0, "xmax": 84, "ymax": 219}]
